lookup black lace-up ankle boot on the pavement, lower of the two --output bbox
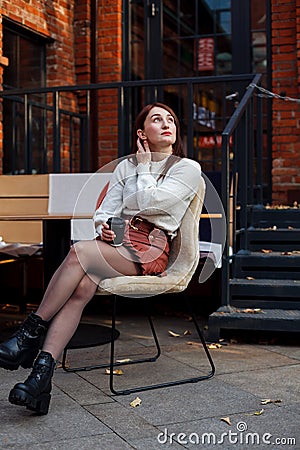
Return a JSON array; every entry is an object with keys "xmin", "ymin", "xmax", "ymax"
[{"xmin": 8, "ymin": 352, "xmax": 55, "ymax": 415}]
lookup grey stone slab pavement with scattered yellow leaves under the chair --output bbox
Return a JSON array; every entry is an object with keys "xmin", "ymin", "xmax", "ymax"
[{"xmin": 0, "ymin": 315, "xmax": 300, "ymax": 450}]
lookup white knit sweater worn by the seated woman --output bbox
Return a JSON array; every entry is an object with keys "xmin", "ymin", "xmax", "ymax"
[{"xmin": 94, "ymin": 158, "xmax": 201, "ymax": 238}]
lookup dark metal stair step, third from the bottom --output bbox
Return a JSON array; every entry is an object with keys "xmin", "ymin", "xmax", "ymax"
[{"xmin": 233, "ymin": 252, "xmax": 300, "ymax": 280}]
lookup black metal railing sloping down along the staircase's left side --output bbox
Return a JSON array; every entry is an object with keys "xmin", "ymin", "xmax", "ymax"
[{"xmin": 221, "ymin": 74, "xmax": 263, "ymax": 310}]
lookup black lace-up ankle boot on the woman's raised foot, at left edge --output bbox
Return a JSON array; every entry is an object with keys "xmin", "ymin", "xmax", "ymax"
[{"xmin": 0, "ymin": 313, "xmax": 47, "ymax": 370}]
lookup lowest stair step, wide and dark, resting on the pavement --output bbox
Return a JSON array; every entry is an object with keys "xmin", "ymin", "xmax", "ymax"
[{"xmin": 207, "ymin": 307, "xmax": 300, "ymax": 341}]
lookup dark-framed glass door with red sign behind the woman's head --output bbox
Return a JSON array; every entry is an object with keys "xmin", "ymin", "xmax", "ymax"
[{"xmin": 124, "ymin": 0, "xmax": 271, "ymax": 196}]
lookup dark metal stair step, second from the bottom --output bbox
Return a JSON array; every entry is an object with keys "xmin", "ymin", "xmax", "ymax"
[{"xmin": 229, "ymin": 278, "xmax": 300, "ymax": 310}]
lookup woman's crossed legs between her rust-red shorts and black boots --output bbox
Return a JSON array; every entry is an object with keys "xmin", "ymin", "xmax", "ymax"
[{"xmin": 37, "ymin": 241, "xmax": 140, "ymax": 359}]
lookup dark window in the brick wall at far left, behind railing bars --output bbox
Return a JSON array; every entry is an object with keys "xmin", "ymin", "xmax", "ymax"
[{"xmin": 3, "ymin": 19, "xmax": 46, "ymax": 174}]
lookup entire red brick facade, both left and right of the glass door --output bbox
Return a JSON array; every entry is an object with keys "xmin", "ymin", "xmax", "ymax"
[{"xmin": 0, "ymin": 0, "xmax": 300, "ymax": 203}]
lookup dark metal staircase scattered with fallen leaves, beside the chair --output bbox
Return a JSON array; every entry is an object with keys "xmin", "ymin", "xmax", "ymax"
[{"xmin": 208, "ymin": 80, "xmax": 300, "ymax": 341}]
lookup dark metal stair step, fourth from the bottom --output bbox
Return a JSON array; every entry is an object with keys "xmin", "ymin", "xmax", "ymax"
[{"xmin": 240, "ymin": 228, "xmax": 300, "ymax": 252}]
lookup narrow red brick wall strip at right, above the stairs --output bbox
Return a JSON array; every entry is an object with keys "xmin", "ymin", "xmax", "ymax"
[{"xmin": 272, "ymin": 0, "xmax": 300, "ymax": 204}]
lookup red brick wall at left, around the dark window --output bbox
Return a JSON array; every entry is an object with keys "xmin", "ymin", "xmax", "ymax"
[{"xmin": 0, "ymin": 0, "xmax": 122, "ymax": 173}]
